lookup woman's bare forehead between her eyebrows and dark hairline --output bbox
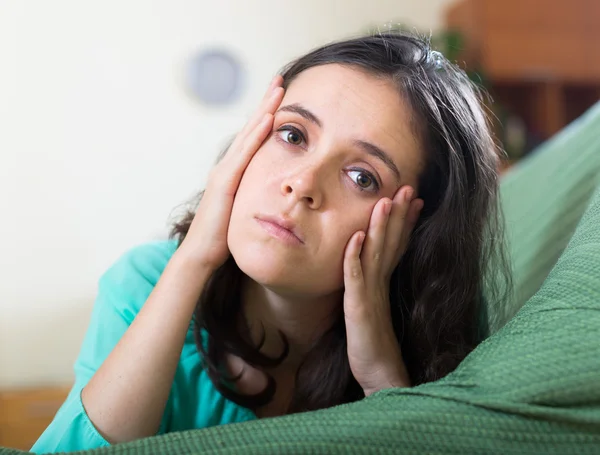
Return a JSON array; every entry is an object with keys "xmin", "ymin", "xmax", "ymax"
[{"xmin": 282, "ymin": 64, "xmax": 420, "ymax": 170}]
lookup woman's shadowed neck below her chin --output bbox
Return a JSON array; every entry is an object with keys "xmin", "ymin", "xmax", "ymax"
[{"xmin": 242, "ymin": 276, "xmax": 343, "ymax": 370}]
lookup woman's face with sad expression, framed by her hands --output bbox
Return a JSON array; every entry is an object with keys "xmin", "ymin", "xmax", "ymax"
[{"xmin": 228, "ymin": 64, "xmax": 424, "ymax": 296}]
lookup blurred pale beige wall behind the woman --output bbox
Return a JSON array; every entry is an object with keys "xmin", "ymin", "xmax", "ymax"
[{"xmin": 0, "ymin": 0, "xmax": 448, "ymax": 386}]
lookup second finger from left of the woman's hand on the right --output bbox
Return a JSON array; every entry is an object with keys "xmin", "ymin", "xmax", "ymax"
[{"xmin": 362, "ymin": 198, "xmax": 392, "ymax": 279}]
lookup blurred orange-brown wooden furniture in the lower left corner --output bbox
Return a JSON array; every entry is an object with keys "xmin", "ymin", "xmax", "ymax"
[{"xmin": 0, "ymin": 387, "xmax": 69, "ymax": 450}]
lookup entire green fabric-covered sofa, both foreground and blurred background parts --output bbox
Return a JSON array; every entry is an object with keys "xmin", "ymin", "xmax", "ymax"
[{"xmin": 0, "ymin": 106, "xmax": 600, "ymax": 455}]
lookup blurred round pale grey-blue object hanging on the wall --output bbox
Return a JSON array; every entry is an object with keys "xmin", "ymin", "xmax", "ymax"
[{"xmin": 187, "ymin": 49, "xmax": 243, "ymax": 105}]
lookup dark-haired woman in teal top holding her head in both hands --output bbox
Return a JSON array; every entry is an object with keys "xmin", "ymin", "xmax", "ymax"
[{"xmin": 32, "ymin": 33, "xmax": 508, "ymax": 451}]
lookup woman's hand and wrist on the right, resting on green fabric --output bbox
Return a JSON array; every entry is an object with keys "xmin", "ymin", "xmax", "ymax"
[{"xmin": 344, "ymin": 186, "xmax": 423, "ymax": 396}]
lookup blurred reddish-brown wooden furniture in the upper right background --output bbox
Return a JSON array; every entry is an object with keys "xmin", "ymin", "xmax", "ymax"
[{"xmin": 446, "ymin": 0, "xmax": 600, "ymax": 140}]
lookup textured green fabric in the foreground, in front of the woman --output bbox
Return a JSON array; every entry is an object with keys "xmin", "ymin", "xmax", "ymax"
[{"xmin": 74, "ymin": 166, "xmax": 600, "ymax": 455}]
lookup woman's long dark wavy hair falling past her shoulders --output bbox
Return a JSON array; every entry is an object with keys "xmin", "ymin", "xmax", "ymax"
[{"xmin": 171, "ymin": 32, "xmax": 510, "ymax": 413}]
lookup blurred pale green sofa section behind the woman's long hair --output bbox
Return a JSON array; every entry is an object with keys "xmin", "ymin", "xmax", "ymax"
[{"xmin": 487, "ymin": 103, "xmax": 600, "ymax": 333}]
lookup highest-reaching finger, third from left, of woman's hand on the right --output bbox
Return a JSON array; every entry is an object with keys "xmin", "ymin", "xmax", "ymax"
[{"xmin": 384, "ymin": 185, "xmax": 415, "ymax": 270}]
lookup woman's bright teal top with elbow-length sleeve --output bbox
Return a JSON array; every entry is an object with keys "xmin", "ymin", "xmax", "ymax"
[{"xmin": 31, "ymin": 240, "xmax": 257, "ymax": 453}]
